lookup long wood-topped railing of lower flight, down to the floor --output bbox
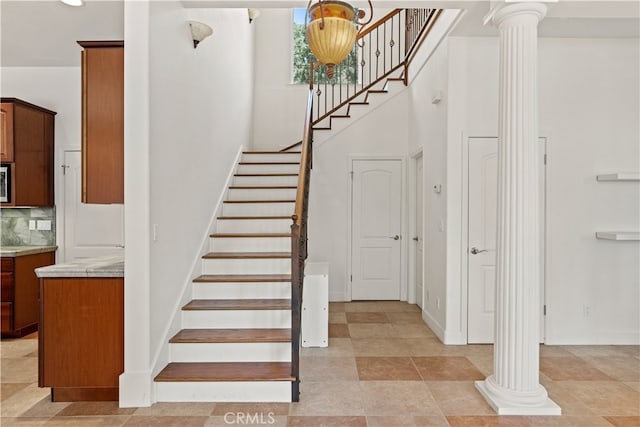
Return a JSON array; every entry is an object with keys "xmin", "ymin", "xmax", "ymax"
[{"xmin": 291, "ymin": 78, "xmax": 313, "ymax": 402}]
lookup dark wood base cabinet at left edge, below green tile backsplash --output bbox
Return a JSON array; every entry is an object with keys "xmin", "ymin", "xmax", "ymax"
[{"xmin": 0, "ymin": 250, "xmax": 55, "ymax": 338}]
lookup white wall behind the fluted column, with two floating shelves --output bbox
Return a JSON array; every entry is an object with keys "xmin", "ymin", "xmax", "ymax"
[{"xmin": 446, "ymin": 38, "xmax": 640, "ymax": 344}]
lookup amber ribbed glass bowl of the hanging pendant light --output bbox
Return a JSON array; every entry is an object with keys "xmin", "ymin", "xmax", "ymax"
[{"xmin": 307, "ymin": 1, "xmax": 358, "ymax": 78}]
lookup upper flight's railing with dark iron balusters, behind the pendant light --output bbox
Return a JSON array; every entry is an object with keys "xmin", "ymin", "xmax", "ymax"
[{"xmin": 312, "ymin": 9, "xmax": 440, "ymax": 125}]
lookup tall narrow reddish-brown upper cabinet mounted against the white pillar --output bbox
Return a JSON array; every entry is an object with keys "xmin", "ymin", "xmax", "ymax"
[{"xmin": 78, "ymin": 41, "xmax": 124, "ymax": 204}]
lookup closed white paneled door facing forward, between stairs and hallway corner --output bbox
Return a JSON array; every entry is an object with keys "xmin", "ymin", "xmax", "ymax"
[{"xmin": 351, "ymin": 160, "xmax": 402, "ymax": 300}]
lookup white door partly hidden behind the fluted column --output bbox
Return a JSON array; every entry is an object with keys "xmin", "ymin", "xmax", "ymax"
[{"xmin": 467, "ymin": 138, "xmax": 545, "ymax": 343}]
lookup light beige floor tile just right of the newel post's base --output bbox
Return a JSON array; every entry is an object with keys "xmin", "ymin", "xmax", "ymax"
[{"xmin": 289, "ymin": 381, "xmax": 365, "ymax": 416}]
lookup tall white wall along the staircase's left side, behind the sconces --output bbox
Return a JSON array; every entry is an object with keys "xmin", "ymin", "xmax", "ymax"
[{"xmin": 120, "ymin": 2, "xmax": 254, "ymax": 406}]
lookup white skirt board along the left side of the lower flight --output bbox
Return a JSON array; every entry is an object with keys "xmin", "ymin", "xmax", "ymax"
[{"xmin": 149, "ymin": 146, "xmax": 244, "ymax": 403}]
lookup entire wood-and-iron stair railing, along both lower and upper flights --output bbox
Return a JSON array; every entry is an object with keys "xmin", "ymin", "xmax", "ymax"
[{"xmin": 288, "ymin": 9, "xmax": 440, "ymax": 402}]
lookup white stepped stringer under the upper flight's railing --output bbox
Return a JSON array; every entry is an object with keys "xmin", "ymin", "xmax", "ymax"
[{"xmin": 313, "ymin": 79, "xmax": 407, "ymax": 148}]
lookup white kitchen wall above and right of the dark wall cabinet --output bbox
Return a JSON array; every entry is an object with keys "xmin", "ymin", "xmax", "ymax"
[{"xmin": 0, "ymin": 67, "xmax": 82, "ymax": 262}]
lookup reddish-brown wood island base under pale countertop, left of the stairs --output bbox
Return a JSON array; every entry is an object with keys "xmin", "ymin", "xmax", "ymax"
[{"xmin": 38, "ymin": 277, "xmax": 124, "ymax": 402}]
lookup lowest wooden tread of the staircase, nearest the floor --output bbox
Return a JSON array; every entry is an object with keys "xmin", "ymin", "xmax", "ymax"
[{"xmin": 154, "ymin": 362, "xmax": 295, "ymax": 382}]
